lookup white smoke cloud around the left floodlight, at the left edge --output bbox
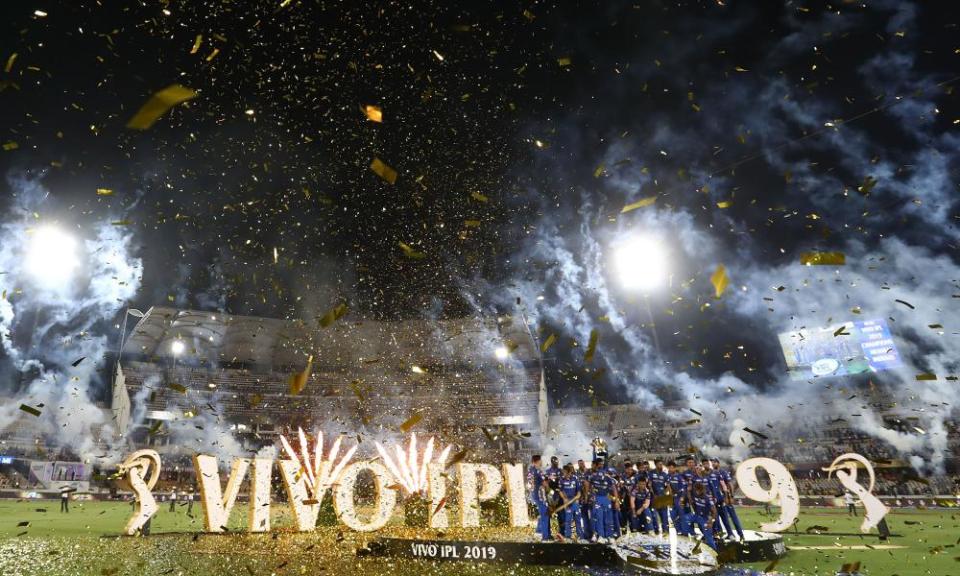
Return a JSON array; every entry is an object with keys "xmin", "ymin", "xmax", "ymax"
[{"xmin": 0, "ymin": 175, "xmax": 142, "ymax": 459}]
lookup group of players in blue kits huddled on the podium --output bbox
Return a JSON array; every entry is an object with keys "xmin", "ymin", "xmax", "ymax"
[{"xmin": 527, "ymin": 454, "xmax": 744, "ymax": 549}]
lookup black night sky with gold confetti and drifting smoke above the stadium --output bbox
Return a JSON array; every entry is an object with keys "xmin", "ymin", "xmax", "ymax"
[{"xmin": 0, "ymin": 0, "xmax": 960, "ymax": 462}]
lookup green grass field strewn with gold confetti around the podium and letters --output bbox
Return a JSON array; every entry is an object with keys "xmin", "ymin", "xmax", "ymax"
[{"xmin": 0, "ymin": 500, "xmax": 960, "ymax": 576}]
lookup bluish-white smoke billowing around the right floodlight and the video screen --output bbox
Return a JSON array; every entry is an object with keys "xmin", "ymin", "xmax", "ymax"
[{"xmin": 465, "ymin": 1, "xmax": 960, "ymax": 473}]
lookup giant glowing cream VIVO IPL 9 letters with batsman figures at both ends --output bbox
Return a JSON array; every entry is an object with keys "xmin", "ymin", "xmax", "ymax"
[{"xmin": 120, "ymin": 431, "xmax": 888, "ymax": 536}]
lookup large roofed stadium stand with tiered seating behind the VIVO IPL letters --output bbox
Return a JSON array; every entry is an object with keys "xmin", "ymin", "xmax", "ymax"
[{"xmin": 112, "ymin": 307, "xmax": 547, "ymax": 454}]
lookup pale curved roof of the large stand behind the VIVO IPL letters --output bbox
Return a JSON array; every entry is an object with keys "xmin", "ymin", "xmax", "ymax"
[{"xmin": 122, "ymin": 306, "xmax": 539, "ymax": 368}]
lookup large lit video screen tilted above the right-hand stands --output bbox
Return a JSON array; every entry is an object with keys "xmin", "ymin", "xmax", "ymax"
[{"xmin": 780, "ymin": 320, "xmax": 902, "ymax": 380}]
